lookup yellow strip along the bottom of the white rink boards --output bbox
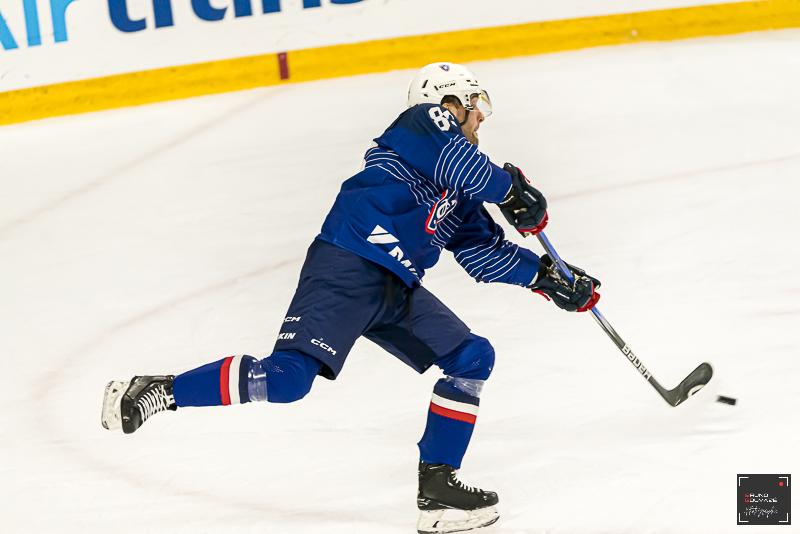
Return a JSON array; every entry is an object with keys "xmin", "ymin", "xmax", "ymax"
[{"xmin": 0, "ymin": 0, "xmax": 800, "ymax": 125}]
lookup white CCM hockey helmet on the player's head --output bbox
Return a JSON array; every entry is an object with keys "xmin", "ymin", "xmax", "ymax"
[{"xmin": 408, "ymin": 62, "xmax": 492, "ymax": 117}]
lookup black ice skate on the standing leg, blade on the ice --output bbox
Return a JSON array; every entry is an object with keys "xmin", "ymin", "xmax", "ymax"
[{"xmin": 417, "ymin": 462, "xmax": 500, "ymax": 534}]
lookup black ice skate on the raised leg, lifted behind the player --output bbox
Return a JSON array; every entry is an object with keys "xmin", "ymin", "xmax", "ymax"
[{"xmin": 102, "ymin": 375, "xmax": 178, "ymax": 434}]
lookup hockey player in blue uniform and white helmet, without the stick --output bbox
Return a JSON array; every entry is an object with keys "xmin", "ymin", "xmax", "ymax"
[{"xmin": 102, "ymin": 63, "xmax": 600, "ymax": 533}]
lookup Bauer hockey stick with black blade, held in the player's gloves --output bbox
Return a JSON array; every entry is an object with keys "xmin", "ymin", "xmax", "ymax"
[{"xmin": 536, "ymin": 232, "xmax": 714, "ymax": 406}]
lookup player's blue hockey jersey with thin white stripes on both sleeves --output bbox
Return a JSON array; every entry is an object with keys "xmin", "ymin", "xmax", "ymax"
[{"xmin": 317, "ymin": 104, "xmax": 539, "ymax": 287}]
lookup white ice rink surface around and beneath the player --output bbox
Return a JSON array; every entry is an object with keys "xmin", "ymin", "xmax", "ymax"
[{"xmin": 0, "ymin": 31, "xmax": 800, "ymax": 534}]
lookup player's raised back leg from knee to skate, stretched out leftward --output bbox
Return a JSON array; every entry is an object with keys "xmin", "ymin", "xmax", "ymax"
[{"xmin": 102, "ymin": 351, "xmax": 322, "ymax": 434}]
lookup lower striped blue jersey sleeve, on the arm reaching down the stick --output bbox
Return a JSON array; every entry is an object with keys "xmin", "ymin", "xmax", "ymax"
[{"xmin": 445, "ymin": 206, "xmax": 539, "ymax": 287}]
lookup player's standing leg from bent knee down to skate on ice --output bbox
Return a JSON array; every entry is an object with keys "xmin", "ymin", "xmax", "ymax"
[{"xmin": 417, "ymin": 334, "xmax": 499, "ymax": 534}]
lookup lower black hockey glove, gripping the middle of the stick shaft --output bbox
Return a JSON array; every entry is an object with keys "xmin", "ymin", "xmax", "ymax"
[{"xmin": 528, "ymin": 254, "xmax": 600, "ymax": 312}]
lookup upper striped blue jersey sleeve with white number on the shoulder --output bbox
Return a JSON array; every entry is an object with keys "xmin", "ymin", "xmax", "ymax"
[{"xmin": 375, "ymin": 104, "xmax": 511, "ymax": 203}]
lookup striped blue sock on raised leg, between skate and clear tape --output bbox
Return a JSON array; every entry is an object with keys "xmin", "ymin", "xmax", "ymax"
[{"xmin": 172, "ymin": 356, "xmax": 256, "ymax": 408}]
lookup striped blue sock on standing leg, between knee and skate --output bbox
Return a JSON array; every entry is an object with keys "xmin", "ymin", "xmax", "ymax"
[{"xmin": 419, "ymin": 377, "xmax": 483, "ymax": 469}]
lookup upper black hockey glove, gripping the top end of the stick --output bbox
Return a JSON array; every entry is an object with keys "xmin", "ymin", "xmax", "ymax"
[{"xmin": 498, "ymin": 163, "xmax": 547, "ymax": 236}]
